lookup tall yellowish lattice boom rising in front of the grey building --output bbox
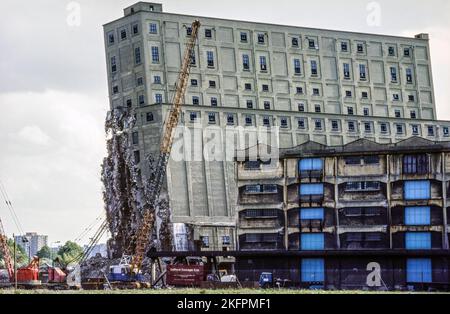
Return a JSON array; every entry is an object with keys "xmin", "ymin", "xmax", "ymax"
[{"xmin": 131, "ymin": 20, "xmax": 200, "ymax": 273}]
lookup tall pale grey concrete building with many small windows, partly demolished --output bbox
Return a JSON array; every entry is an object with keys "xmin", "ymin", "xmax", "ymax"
[{"xmin": 104, "ymin": 2, "xmax": 450, "ymax": 249}]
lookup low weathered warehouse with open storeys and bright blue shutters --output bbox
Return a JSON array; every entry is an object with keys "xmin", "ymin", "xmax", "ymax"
[{"xmin": 236, "ymin": 137, "xmax": 450, "ymax": 289}]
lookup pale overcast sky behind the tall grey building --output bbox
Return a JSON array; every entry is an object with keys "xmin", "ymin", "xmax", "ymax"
[{"xmin": 0, "ymin": 0, "xmax": 450, "ymax": 243}]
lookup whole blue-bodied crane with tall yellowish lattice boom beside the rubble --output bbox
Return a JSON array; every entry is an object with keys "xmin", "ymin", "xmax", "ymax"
[{"xmin": 107, "ymin": 20, "xmax": 200, "ymax": 288}]
